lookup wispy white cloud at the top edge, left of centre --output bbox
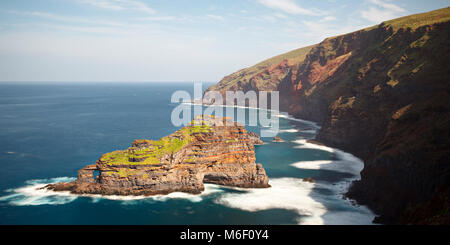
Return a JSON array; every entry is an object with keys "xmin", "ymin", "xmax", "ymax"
[{"xmin": 79, "ymin": 0, "xmax": 156, "ymax": 14}]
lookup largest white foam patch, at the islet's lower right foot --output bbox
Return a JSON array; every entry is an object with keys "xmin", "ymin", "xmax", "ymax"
[{"xmin": 215, "ymin": 178, "xmax": 373, "ymax": 225}]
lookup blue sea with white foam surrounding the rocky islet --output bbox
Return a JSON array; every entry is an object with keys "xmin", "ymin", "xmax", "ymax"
[{"xmin": 0, "ymin": 83, "xmax": 374, "ymax": 224}]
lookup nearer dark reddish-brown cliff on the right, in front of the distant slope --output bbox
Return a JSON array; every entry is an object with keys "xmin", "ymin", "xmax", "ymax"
[{"xmin": 207, "ymin": 8, "xmax": 450, "ymax": 223}]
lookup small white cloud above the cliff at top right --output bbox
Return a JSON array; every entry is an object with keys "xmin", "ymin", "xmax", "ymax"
[{"xmin": 361, "ymin": 0, "xmax": 406, "ymax": 23}]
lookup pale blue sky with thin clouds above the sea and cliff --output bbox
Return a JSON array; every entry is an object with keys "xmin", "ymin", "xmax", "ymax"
[{"xmin": 0, "ymin": 0, "xmax": 450, "ymax": 82}]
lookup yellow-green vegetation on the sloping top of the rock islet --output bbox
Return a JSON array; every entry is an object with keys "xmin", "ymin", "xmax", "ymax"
[{"xmin": 100, "ymin": 121, "xmax": 211, "ymax": 166}]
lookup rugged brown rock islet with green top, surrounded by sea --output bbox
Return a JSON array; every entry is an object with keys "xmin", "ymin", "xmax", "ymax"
[{"xmin": 46, "ymin": 116, "xmax": 269, "ymax": 195}]
